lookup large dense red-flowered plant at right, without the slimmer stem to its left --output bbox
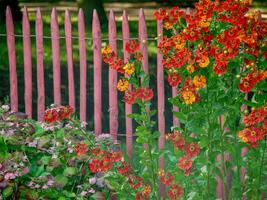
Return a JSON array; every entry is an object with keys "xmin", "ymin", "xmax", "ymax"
[{"xmin": 155, "ymin": 0, "xmax": 267, "ymax": 199}]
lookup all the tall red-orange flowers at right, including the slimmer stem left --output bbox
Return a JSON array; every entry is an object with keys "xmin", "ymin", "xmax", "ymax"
[{"xmin": 102, "ymin": 0, "xmax": 267, "ymax": 199}]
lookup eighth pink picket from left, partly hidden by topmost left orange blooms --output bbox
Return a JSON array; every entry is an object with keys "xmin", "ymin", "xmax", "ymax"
[{"xmin": 108, "ymin": 10, "xmax": 119, "ymax": 140}]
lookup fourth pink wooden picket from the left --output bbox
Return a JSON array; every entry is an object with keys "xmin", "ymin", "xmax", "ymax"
[{"xmin": 51, "ymin": 8, "xmax": 61, "ymax": 105}]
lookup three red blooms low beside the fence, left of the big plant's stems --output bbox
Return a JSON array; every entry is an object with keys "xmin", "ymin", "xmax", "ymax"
[{"xmin": 166, "ymin": 131, "xmax": 200, "ymax": 176}]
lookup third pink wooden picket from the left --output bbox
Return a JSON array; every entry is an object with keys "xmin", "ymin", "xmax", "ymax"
[{"xmin": 35, "ymin": 8, "xmax": 45, "ymax": 121}]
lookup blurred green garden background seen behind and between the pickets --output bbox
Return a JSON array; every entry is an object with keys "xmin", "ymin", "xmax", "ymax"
[{"xmin": 0, "ymin": 0, "xmax": 267, "ymax": 133}]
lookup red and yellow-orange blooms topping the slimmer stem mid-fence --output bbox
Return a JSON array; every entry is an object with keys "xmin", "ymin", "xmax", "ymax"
[{"xmin": 102, "ymin": 40, "xmax": 154, "ymax": 104}]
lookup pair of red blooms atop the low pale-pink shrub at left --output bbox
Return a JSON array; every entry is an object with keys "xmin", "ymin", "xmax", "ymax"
[{"xmin": 44, "ymin": 105, "xmax": 73, "ymax": 123}]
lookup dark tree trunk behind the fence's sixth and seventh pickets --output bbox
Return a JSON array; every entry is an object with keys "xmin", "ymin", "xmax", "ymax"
[{"xmin": 77, "ymin": 0, "xmax": 107, "ymax": 27}]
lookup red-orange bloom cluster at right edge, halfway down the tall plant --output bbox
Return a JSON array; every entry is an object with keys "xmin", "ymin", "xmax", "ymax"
[{"xmin": 238, "ymin": 104, "xmax": 267, "ymax": 148}]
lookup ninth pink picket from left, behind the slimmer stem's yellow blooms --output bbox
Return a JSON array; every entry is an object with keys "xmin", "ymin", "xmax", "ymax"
[{"xmin": 122, "ymin": 10, "xmax": 133, "ymax": 162}]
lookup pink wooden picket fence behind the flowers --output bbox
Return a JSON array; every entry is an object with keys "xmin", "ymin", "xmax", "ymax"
[{"xmin": 3, "ymin": 7, "xmax": 232, "ymax": 197}]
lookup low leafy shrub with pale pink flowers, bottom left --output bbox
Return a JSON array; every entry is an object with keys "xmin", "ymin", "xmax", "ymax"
[{"xmin": 0, "ymin": 105, "xmax": 122, "ymax": 200}]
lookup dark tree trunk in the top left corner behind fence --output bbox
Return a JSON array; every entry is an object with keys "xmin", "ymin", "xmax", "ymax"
[{"xmin": 0, "ymin": 0, "xmax": 22, "ymax": 21}]
